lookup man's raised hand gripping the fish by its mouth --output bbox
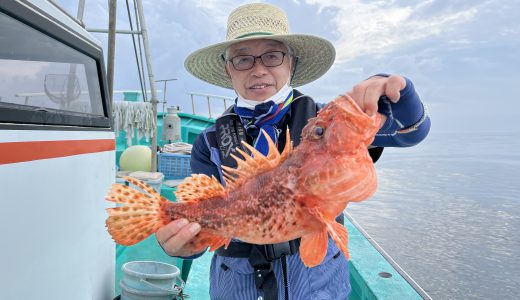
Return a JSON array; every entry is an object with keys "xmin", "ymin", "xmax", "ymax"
[{"xmin": 347, "ymin": 75, "xmax": 406, "ymax": 116}]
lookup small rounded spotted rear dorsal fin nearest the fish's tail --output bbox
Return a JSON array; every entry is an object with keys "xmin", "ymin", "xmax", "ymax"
[{"xmin": 175, "ymin": 174, "xmax": 225, "ymax": 202}]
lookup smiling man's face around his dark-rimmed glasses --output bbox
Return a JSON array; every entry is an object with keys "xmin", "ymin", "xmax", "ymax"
[{"xmin": 226, "ymin": 40, "xmax": 291, "ymax": 101}]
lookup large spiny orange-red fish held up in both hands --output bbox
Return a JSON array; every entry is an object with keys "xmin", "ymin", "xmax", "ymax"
[{"xmin": 106, "ymin": 95, "xmax": 381, "ymax": 267}]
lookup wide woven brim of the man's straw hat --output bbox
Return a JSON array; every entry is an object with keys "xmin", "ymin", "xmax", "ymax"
[{"xmin": 184, "ymin": 34, "xmax": 336, "ymax": 89}]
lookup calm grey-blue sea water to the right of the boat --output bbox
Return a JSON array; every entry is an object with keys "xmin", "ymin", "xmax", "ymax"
[{"xmin": 347, "ymin": 132, "xmax": 520, "ymax": 299}]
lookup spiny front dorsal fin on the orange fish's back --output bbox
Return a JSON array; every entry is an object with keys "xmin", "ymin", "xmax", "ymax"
[{"xmin": 222, "ymin": 129, "xmax": 293, "ymax": 190}]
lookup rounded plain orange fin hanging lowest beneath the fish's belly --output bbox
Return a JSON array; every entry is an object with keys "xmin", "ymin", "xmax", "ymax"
[{"xmin": 300, "ymin": 230, "xmax": 329, "ymax": 268}]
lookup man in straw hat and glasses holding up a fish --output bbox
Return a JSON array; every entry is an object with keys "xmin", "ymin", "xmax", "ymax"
[{"xmin": 156, "ymin": 3, "xmax": 430, "ymax": 300}]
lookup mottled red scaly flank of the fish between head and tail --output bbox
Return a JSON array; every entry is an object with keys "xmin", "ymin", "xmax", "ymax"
[{"xmin": 164, "ymin": 168, "xmax": 304, "ymax": 244}]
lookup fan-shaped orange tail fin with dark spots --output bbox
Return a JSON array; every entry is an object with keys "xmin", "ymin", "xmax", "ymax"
[{"xmin": 106, "ymin": 177, "xmax": 170, "ymax": 246}]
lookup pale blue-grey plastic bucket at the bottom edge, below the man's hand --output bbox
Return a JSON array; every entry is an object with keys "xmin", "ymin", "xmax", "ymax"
[{"xmin": 119, "ymin": 261, "xmax": 184, "ymax": 300}]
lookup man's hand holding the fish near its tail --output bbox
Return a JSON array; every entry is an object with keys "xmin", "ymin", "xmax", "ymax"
[{"xmin": 155, "ymin": 219, "xmax": 200, "ymax": 257}]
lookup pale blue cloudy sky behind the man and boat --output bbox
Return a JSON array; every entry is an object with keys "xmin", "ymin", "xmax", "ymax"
[{"xmin": 55, "ymin": 0, "xmax": 520, "ymax": 133}]
